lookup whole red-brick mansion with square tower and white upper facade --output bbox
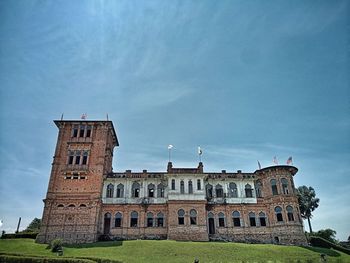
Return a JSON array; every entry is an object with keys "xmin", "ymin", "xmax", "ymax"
[{"xmin": 37, "ymin": 120, "xmax": 306, "ymax": 244}]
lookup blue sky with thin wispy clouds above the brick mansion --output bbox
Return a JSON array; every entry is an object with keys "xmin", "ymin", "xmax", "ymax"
[{"xmin": 0, "ymin": 0, "xmax": 350, "ymax": 240}]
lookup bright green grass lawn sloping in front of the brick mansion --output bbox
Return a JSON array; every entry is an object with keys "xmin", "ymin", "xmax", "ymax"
[{"xmin": 0, "ymin": 239, "xmax": 350, "ymax": 263}]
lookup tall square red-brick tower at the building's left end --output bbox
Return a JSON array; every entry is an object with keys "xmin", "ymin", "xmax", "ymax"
[{"xmin": 37, "ymin": 120, "xmax": 119, "ymax": 243}]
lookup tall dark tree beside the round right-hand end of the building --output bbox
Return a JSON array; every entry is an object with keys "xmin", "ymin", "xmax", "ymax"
[{"xmin": 298, "ymin": 185, "xmax": 320, "ymax": 234}]
